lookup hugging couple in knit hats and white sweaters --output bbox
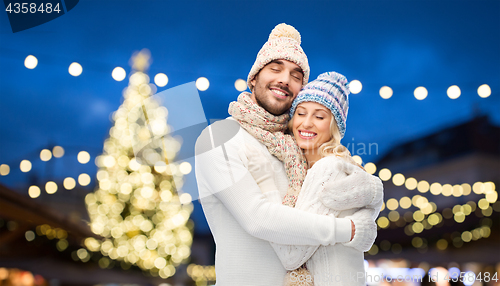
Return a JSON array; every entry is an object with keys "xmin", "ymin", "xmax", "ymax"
[{"xmin": 195, "ymin": 24, "xmax": 383, "ymax": 286}]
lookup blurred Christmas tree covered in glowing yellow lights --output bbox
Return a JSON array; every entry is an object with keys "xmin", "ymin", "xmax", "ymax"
[{"xmin": 85, "ymin": 50, "xmax": 193, "ymax": 278}]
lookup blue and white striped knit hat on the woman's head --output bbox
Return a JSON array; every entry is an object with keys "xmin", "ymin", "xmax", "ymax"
[{"xmin": 290, "ymin": 72, "xmax": 350, "ymax": 138}]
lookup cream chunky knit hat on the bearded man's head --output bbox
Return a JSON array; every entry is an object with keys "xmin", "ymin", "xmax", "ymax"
[{"xmin": 247, "ymin": 23, "xmax": 309, "ymax": 90}]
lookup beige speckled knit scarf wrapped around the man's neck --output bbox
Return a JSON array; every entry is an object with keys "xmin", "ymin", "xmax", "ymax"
[{"xmin": 229, "ymin": 92, "xmax": 307, "ymax": 207}]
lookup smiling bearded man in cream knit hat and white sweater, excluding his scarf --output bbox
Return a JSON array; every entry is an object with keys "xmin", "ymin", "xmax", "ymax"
[{"xmin": 195, "ymin": 24, "xmax": 376, "ymax": 286}]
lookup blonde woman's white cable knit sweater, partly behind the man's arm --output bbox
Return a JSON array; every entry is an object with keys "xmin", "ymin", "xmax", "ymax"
[{"xmin": 265, "ymin": 156, "xmax": 383, "ymax": 286}]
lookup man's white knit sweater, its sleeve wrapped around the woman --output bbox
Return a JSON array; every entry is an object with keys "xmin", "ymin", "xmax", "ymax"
[{"xmin": 195, "ymin": 119, "xmax": 373, "ymax": 286}]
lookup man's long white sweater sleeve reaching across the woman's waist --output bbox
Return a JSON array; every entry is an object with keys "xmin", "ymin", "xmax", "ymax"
[{"xmin": 195, "ymin": 123, "xmax": 348, "ymax": 245}]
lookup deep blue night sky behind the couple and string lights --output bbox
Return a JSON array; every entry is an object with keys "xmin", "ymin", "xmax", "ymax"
[{"xmin": 0, "ymin": 0, "xmax": 500, "ymax": 232}]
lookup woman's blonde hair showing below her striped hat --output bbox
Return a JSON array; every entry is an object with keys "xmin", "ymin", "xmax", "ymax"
[{"xmin": 288, "ymin": 111, "xmax": 365, "ymax": 170}]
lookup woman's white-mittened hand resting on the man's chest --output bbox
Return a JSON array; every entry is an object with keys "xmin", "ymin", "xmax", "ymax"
[{"xmin": 238, "ymin": 144, "xmax": 278, "ymax": 193}]
